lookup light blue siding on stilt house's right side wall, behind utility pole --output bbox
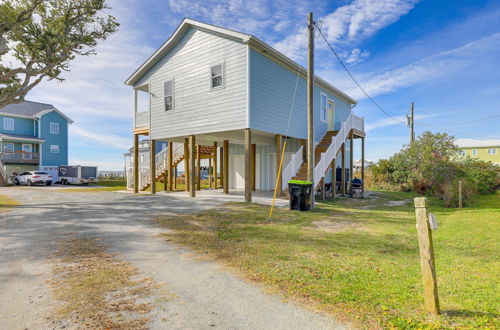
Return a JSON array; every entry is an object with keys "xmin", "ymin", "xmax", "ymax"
[{"xmin": 250, "ymin": 49, "xmax": 351, "ymax": 141}]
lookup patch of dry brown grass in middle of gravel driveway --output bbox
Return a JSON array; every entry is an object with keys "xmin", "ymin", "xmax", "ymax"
[{"xmin": 47, "ymin": 235, "xmax": 159, "ymax": 329}]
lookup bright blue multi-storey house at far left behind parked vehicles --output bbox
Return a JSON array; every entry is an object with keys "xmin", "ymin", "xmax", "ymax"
[{"xmin": 0, "ymin": 101, "xmax": 73, "ymax": 180}]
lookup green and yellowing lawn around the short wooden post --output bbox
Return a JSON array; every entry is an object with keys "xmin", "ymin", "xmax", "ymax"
[{"xmin": 154, "ymin": 193, "xmax": 500, "ymax": 328}]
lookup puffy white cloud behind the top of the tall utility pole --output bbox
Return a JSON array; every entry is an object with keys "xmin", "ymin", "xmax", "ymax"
[{"xmin": 274, "ymin": 0, "xmax": 418, "ymax": 59}]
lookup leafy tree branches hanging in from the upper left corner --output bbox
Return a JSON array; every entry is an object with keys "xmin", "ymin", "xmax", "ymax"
[{"xmin": 0, "ymin": 0, "xmax": 119, "ymax": 108}]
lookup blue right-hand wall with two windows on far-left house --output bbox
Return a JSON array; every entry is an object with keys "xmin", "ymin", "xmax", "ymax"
[{"xmin": 40, "ymin": 111, "xmax": 68, "ymax": 166}]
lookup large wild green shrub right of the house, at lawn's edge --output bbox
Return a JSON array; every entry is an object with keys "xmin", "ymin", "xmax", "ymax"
[{"xmin": 370, "ymin": 132, "xmax": 500, "ymax": 207}]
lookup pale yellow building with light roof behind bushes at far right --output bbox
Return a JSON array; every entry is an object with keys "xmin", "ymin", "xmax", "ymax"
[{"xmin": 455, "ymin": 139, "xmax": 500, "ymax": 165}]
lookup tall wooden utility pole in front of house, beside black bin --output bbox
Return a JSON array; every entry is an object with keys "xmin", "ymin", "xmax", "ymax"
[{"xmin": 307, "ymin": 13, "xmax": 315, "ymax": 208}]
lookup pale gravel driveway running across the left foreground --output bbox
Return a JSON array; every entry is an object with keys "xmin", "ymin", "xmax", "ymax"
[{"xmin": 0, "ymin": 187, "xmax": 342, "ymax": 330}]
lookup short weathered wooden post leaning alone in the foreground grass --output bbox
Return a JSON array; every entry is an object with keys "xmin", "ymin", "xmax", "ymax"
[{"xmin": 414, "ymin": 197, "xmax": 440, "ymax": 315}]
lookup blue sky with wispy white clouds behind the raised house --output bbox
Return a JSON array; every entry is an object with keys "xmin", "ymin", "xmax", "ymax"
[{"xmin": 27, "ymin": 0, "xmax": 500, "ymax": 170}]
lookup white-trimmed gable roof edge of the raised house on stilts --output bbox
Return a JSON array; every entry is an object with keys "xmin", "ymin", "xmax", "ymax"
[{"xmin": 125, "ymin": 18, "xmax": 357, "ymax": 104}]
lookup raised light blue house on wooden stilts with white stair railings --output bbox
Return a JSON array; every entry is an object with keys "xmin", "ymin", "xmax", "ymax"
[{"xmin": 126, "ymin": 19, "xmax": 365, "ymax": 201}]
